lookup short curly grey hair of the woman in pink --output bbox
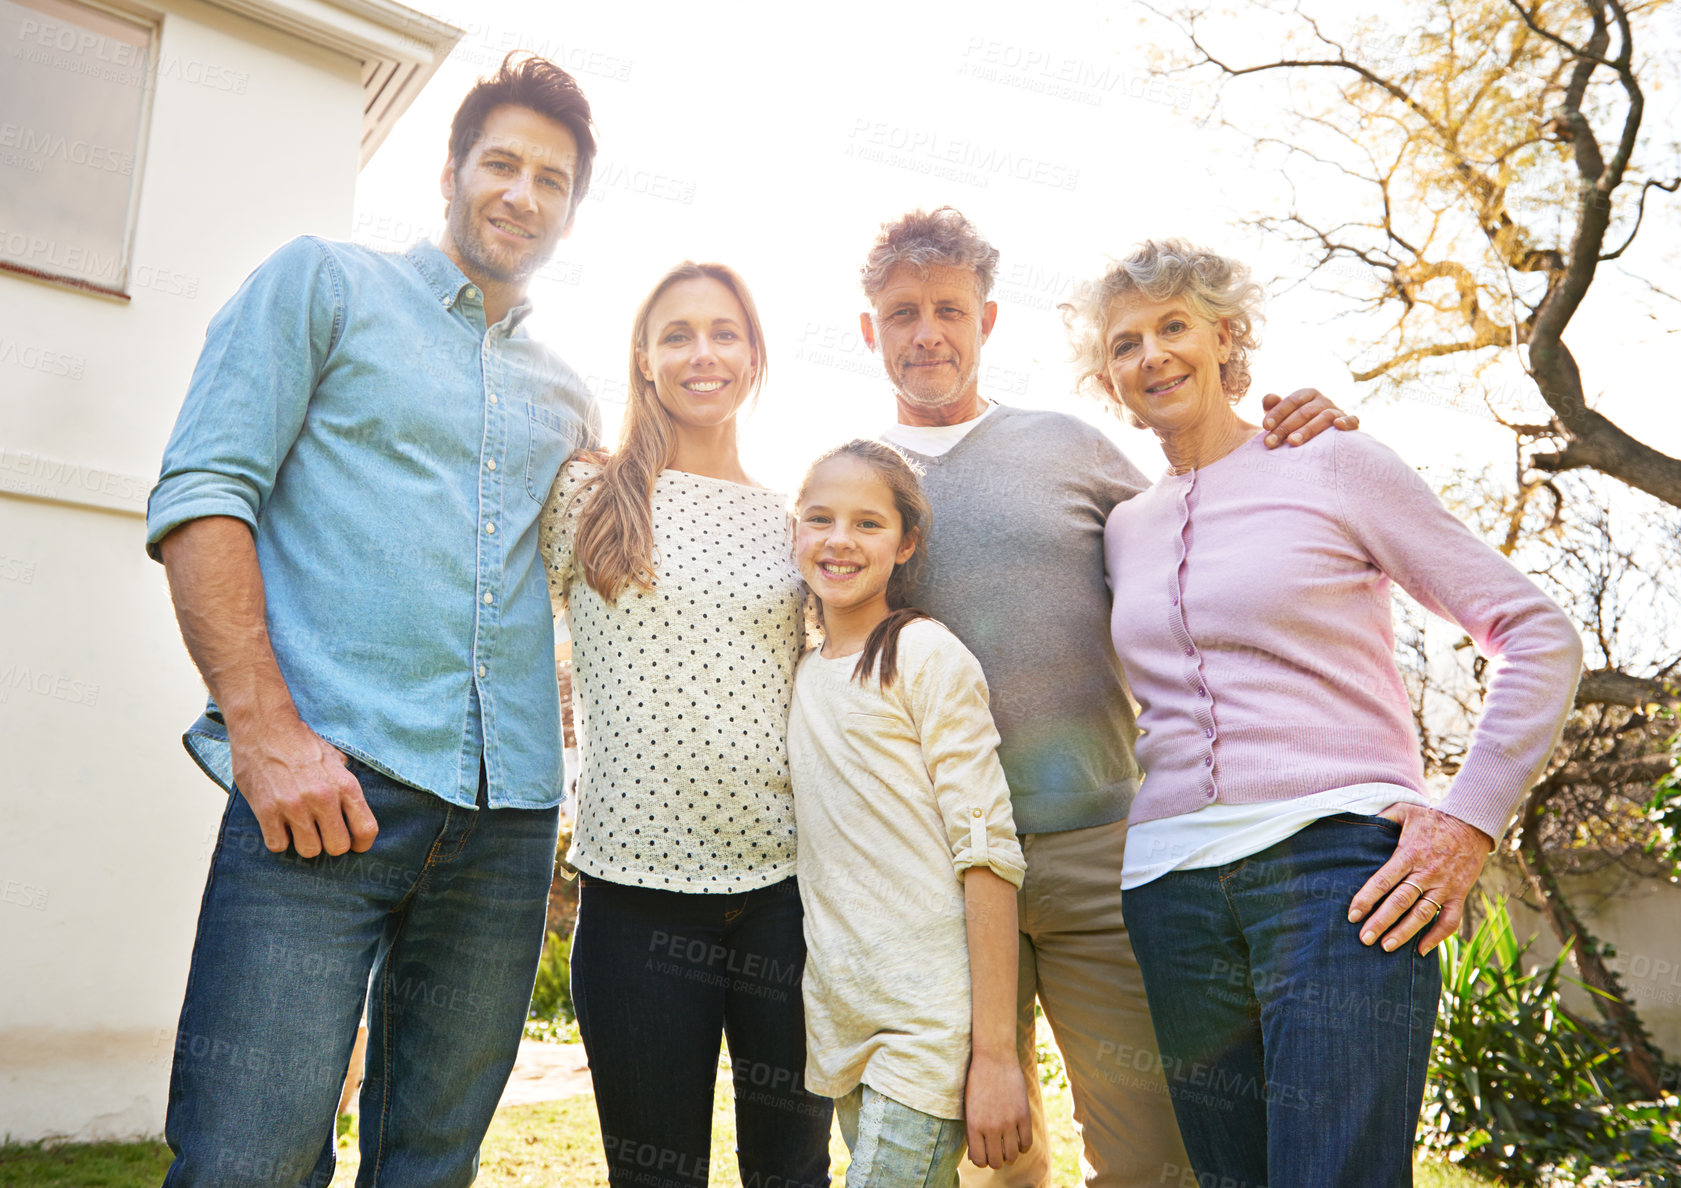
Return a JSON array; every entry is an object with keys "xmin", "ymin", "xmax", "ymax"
[{"xmin": 1057, "ymin": 239, "xmax": 1262, "ymax": 403}]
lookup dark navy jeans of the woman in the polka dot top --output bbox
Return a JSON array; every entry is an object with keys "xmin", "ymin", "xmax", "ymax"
[{"xmin": 572, "ymin": 875, "xmax": 834, "ymax": 1188}]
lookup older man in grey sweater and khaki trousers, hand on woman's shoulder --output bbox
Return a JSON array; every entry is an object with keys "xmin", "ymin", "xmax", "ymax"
[{"xmin": 861, "ymin": 207, "xmax": 1357, "ymax": 1188}]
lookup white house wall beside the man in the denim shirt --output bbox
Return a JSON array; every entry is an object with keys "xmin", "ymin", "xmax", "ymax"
[{"xmin": 0, "ymin": 0, "xmax": 363, "ymax": 1139}]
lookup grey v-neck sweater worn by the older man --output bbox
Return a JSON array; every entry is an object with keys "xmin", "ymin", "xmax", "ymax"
[{"xmin": 906, "ymin": 405, "xmax": 1150, "ymax": 833}]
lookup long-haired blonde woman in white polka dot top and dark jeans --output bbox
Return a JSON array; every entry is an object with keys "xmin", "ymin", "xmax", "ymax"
[{"xmin": 540, "ymin": 262, "xmax": 830, "ymax": 1188}]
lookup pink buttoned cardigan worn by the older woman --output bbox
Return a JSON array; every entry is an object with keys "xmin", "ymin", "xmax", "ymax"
[{"xmin": 1104, "ymin": 432, "xmax": 1582, "ymax": 838}]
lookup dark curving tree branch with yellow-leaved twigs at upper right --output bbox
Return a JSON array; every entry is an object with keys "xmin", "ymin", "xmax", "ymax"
[{"xmin": 1146, "ymin": 0, "xmax": 1681, "ymax": 506}]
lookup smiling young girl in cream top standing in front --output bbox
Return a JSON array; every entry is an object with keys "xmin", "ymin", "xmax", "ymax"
[{"xmin": 788, "ymin": 440, "xmax": 1032, "ymax": 1188}]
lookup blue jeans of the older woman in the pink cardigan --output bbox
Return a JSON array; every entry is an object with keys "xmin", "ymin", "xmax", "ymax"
[{"xmin": 1123, "ymin": 813, "xmax": 1442, "ymax": 1188}]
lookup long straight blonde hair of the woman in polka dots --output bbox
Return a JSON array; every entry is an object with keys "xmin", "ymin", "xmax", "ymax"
[{"xmin": 573, "ymin": 260, "xmax": 765, "ymax": 603}]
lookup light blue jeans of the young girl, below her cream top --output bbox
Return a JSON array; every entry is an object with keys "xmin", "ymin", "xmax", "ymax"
[{"xmin": 835, "ymin": 1085, "xmax": 968, "ymax": 1188}]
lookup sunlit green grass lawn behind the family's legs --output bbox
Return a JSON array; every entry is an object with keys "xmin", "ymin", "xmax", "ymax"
[{"xmin": 0, "ymin": 1079, "xmax": 1488, "ymax": 1188}]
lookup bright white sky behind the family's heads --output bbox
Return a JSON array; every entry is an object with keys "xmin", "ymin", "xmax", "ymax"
[{"xmin": 355, "ymin": 0, "xmax": 1681, "ymax": 489}]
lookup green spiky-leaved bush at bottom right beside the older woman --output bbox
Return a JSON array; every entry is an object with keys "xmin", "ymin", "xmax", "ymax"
[{"xmin": 1420, "ymin": 899, "xmax": 1681, "ymax": 1188}]
